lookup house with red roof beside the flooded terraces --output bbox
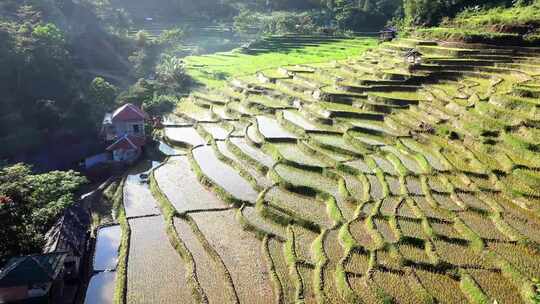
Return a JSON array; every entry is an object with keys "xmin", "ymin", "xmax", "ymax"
[{"xmin": 102, "ymin": 103, "xmax": 148, "ymax": 162}]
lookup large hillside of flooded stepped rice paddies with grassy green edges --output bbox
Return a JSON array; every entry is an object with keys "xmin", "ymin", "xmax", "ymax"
[{"xmin": 152, "ymin": 39, "xmax": 540, "ymax": 303}]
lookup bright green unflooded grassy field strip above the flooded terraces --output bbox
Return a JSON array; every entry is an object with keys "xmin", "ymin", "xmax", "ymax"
[{"xmin": 185, "ymin": 38, "xmax": 377, "ymax": 88}]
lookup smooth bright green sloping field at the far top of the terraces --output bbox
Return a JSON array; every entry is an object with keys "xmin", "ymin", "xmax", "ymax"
[{"xmin": 181, "ymin": 35, "xmax": 376, "ymax": 88}]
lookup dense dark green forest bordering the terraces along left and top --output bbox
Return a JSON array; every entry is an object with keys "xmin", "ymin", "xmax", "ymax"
[{"xmin": 0, "ymin": 0, "xmax": 540, "ymax": 261}]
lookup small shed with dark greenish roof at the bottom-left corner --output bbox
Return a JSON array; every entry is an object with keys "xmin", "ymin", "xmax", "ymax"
[{"xmin": 0, "ymin": 253, "xmax": 66, "ymax": 304}]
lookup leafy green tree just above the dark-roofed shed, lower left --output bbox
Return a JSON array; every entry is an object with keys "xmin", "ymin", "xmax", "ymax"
[{"xmin": 0, "ymin": 164, "xmax": 86, "ymax": 263}]
